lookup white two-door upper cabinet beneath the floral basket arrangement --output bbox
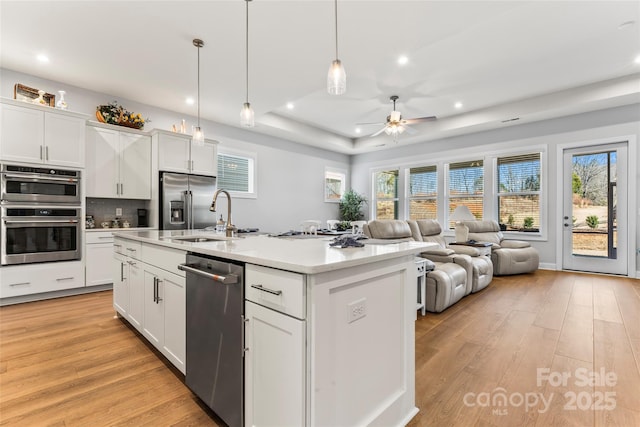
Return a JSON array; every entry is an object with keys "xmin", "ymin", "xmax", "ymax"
[{"xmin": 86, "ymin": 126, "xmax": 151, "ymax": 200}]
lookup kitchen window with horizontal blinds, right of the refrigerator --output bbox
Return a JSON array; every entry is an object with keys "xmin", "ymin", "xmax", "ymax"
[{"xmin": 217, "ymin": 153, "xmax": 257, "ymax": 197}]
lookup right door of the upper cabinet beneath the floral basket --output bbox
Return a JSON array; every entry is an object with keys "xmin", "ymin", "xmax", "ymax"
[{"xmin": 120, "ymin": 132, "xmax": 151, "ymax": 199}]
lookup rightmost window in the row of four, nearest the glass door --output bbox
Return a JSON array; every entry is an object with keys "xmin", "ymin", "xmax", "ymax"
[{"xmin": 497, "ymin": 153, "xmax": 540, "ymax": 231}]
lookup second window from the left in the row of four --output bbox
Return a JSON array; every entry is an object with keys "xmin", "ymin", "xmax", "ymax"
[{"xmin": 409, "ymin": 165, "xmax": 438, "ymax": 219}]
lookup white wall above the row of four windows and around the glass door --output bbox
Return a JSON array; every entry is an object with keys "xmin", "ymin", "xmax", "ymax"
[{"xmin": 351, "ymin": 104, "xmax": 640, "ymax": 277}]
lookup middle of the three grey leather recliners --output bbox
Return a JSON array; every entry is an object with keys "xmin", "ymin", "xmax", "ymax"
[{"xmin": 407, "ymin": 219, "xmax": 493, "ymax": 294}]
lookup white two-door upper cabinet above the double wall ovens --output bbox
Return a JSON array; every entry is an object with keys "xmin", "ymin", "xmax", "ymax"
[{"xmin": 0, "ymin": 100, "xmax": 87, "ymax": 168}]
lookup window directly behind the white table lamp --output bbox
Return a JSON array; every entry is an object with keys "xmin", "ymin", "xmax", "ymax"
[{"xmin": 448, "ymin": 160, "xmax": 484, "ymax": 229}]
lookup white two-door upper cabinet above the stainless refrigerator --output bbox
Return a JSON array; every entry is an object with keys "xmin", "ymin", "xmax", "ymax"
[{"xmin": 152, "ymin": 129, "xmax": 218, "ymax": 176}]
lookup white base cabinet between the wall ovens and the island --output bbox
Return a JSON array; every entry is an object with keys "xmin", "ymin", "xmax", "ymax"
[{"xmin": 84, "ymin": 231, "xmax": 113, "ymax": 286}]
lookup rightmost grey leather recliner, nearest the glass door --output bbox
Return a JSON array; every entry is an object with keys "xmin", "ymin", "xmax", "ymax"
[{"xmin": 463, "ymin": 220, "xmax": 540, "ymax": 276}]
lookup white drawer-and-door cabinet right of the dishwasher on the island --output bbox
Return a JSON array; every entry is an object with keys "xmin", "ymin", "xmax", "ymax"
[{"xmin": 245, "ymin": 264, "xmax": 307, "ymax": 426}]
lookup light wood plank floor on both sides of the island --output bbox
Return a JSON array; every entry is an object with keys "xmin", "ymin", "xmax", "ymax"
[{"xmin": 0, "ymin": 271, "xmax": 640, "ymax": 427}]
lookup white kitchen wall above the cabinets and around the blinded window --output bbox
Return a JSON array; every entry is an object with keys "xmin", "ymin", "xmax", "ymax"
[{"xmin": 0, "ymin": 69, "xmax": 350, "ymax": 232}]
